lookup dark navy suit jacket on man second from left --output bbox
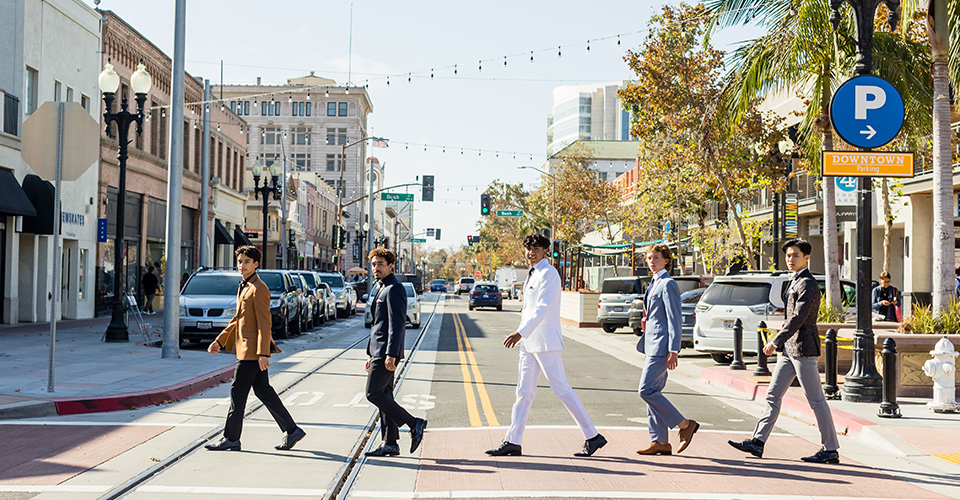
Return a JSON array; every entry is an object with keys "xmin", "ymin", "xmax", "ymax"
[{"xmin": 367, "ymin": 274, "xmax": 407, "ymax": 360}]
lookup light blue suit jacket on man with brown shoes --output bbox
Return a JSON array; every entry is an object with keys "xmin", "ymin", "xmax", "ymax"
[{"xmin": 637, "ymin": 275, "xmax": 683, "ymax": 356}]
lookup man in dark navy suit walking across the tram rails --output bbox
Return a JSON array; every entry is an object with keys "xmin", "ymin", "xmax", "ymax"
[{"xmin": 365, "ymin": 248, "xmax": 427, "ymax": 457}]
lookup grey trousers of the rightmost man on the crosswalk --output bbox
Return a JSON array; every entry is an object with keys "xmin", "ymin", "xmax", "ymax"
[{"xmin": 753, "ymin": 355, "xmax": 840, "ymax": 451}]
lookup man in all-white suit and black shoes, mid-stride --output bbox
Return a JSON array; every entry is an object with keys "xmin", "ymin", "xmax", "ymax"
[{"xmin": 487, "ymin": 234, "xmax": 607, "ymax": 457}]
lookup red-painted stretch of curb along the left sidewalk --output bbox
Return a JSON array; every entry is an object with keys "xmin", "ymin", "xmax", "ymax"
[{"xmin": 45, "ymin": 366, "xmax": 234, "ymax": 415}]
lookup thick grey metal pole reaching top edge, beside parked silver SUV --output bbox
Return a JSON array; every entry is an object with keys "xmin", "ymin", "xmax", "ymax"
[{"xmin": 160, "ymin": 0, "xmax": 187, "ymax": 358}]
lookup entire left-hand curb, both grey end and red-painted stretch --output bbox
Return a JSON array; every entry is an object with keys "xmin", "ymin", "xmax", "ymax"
[{"xmin": 0, "ymin": 366, "xmax": 234, "ymax": 420}]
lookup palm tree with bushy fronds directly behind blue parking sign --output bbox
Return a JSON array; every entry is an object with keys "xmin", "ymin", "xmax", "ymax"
[{"xmin": 706, "ymin": 0, "xmax": 929, "ymax": 308}]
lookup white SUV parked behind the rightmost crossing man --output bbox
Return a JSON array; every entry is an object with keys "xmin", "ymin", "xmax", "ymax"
[{"xmin": 693, "ymin": 271, "xmax": 857, "ymax": 363}]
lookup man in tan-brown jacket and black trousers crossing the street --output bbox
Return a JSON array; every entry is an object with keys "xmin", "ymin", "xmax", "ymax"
[{"xmin": 206, "ymin": 246, "xmax": 307, "ymax": 451}]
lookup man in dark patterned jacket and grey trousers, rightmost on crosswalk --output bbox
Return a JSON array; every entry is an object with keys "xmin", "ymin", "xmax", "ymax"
[{"xmin": 728, "ymin": 239, "xmax": 840, "ymax": 464}]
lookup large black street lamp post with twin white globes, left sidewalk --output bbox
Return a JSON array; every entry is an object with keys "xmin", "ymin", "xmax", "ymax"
[{"xmin": 98, "ymin": 59, "xmax": 153, "ymax": 342}]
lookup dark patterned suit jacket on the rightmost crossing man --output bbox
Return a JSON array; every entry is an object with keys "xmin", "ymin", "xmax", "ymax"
[{"xmin": 771, "ymin": 269, "xmax": 820, "ymax": 358}]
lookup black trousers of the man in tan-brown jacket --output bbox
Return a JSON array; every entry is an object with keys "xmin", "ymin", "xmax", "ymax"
[{"xmin": 223, "ymin": 360, "xmax": 297, "ymax": 441}]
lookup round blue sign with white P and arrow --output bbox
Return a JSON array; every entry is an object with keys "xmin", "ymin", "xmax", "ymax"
[{"xmin": 825, "ymin": 75, "xmax": 904, "ymax": 148}]
